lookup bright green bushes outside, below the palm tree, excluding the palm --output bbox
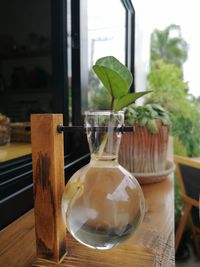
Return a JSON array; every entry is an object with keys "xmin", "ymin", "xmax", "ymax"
[{"xmin": 146, "ymin": 60, "xmax": 200, "ymax": 156}]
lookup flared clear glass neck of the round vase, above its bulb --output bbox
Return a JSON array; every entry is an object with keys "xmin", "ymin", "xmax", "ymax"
[{"xmin": 85, "ymin": 111, "xmax": 124, "ymax": 161}]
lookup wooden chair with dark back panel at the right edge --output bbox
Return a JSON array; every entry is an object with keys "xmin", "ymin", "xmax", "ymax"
[{"xmin": 174, "ymin": 156, "xmax": 200, "ymax": 256}]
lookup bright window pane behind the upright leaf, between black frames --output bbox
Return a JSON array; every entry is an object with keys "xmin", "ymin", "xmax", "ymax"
[{"xmin": 85, "ymin": 0, "xmax": 126, "ymax": 112}]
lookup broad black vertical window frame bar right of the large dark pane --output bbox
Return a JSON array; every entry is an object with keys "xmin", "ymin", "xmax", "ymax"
[{"xmin": 51, "ymin": 0, "xmax": 69, "ymax": 125}]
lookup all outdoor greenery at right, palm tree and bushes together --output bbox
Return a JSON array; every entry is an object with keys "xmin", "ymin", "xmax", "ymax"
[{"xmin": 146, "ymin": 25, "xmax": 200, "ymax": 232}]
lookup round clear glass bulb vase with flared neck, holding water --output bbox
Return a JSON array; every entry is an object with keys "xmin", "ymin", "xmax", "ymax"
[{"xmin": 62, "ymin": 111, "xmax": 145, "ymax": 249}]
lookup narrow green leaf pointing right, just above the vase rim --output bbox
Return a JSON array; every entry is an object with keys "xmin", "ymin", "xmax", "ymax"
[{"xmin": 114, "ymin": 91, "xmax": 151, "ymax": 110}]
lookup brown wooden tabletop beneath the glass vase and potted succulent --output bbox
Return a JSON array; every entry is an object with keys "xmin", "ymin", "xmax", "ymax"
[{"xmin": 0, "ymin": 177, "xmax": 175, "ymax": 267}]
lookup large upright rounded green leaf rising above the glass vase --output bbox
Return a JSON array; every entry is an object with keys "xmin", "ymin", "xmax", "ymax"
[{"xmin": 93, "ymin": 56, "xmax": 133, "ymax": 99}]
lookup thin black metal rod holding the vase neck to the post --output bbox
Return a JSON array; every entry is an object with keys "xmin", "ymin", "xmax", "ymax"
[{"xmin": 57, "ymin": 125, "xmax": 135, "ymax": 134}]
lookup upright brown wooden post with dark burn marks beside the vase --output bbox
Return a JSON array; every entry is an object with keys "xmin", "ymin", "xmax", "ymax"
[{"xmin": 31, "ymin": 114, "xmax": 66, "ymax": 262}]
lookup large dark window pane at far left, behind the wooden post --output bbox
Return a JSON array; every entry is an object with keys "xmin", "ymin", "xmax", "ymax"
[{"xmin": 0, "ymin": 0, "xmax": 52, "ymax": 162}]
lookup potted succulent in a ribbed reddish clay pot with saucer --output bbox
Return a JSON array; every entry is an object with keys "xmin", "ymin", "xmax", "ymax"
[{"xmin": 119, "ymin": 104, "xmax": 173, "ymax": 183}]
